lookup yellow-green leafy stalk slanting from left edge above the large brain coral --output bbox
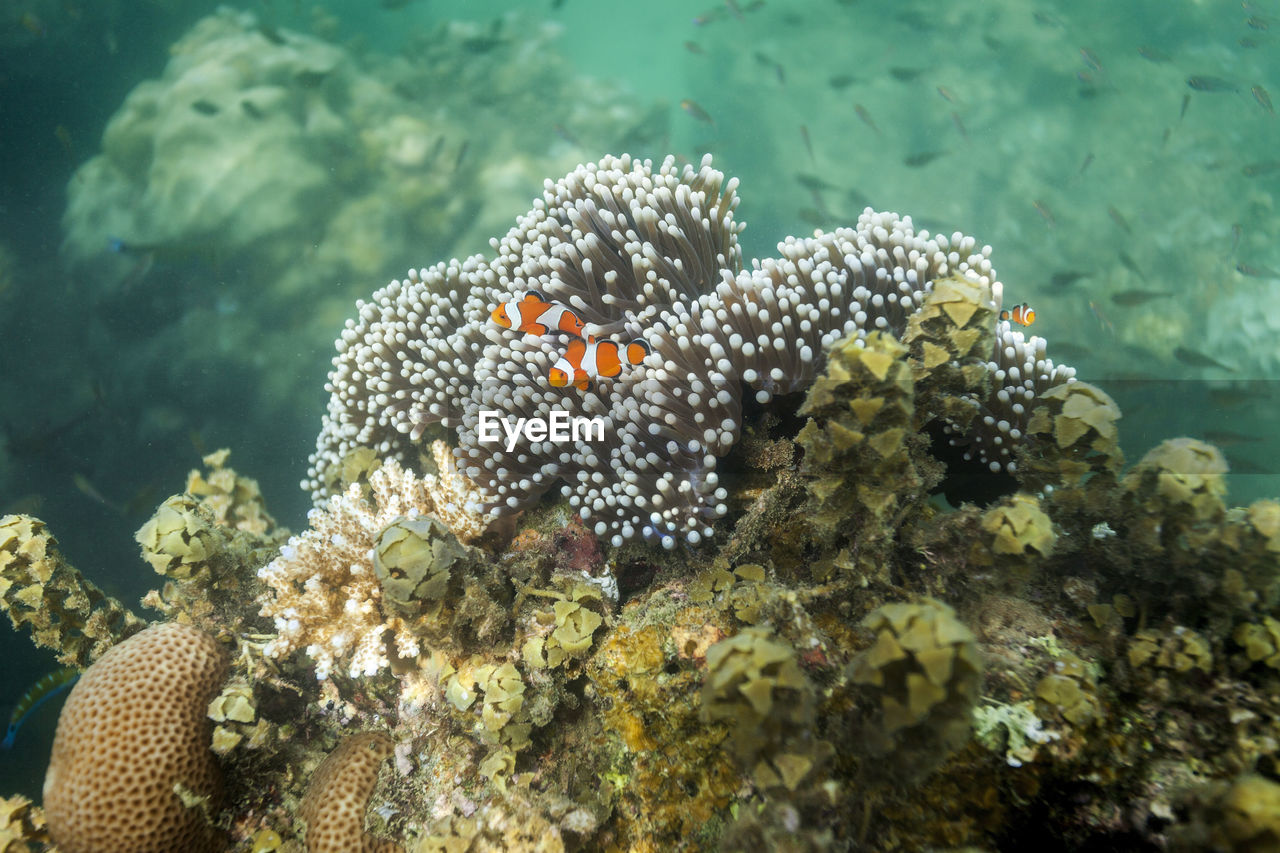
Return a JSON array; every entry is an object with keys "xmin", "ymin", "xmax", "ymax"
[{"xmin": 0, "ymin": 515, "xmax": 145, "ymax": 669}]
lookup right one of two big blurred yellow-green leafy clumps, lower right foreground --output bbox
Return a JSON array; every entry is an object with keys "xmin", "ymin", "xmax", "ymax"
[{"xmin": 846, "ymin": 598, "xmax": 982, "ymax": 777}]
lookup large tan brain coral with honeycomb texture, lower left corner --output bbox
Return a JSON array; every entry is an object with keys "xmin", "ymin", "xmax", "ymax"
[{"xmin": 45, "ymin": 622, "xmax": 227, "ymax": 853}]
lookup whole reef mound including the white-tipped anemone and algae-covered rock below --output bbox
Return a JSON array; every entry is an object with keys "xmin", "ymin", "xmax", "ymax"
[{"xmin": 10, "ymin": 153, "xmax": 1280, "ymax": 852}]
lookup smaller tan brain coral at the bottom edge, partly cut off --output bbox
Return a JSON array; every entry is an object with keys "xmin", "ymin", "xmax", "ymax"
[{"xmin": 298, "ymin": 731, "xmax": 403, "ymax": 853}]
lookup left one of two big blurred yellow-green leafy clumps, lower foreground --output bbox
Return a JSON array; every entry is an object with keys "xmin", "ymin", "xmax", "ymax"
[{"xmin": 701, "ymin": 628, "xmax": 829, "ymax": 790}]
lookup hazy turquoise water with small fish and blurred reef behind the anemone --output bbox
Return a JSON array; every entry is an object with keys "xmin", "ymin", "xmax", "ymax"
[{"xmin": 0, "ymin": 0, "xmax": 1280, "ymax": 794}]
